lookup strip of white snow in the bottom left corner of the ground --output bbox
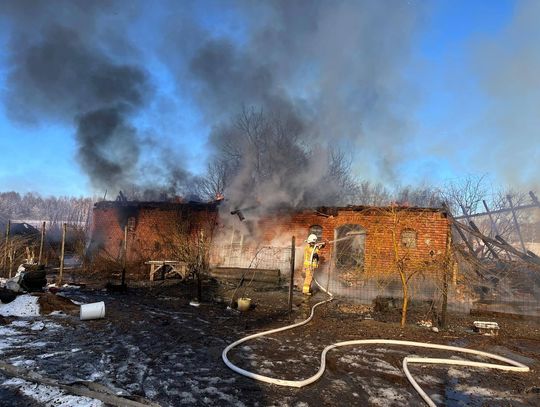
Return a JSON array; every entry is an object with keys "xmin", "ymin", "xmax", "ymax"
[{"xmin": 2, "ymin": 379, "xmax": 104, "ymax": 407}]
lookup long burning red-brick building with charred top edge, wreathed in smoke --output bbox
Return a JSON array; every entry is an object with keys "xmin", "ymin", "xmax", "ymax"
[{"xmin": 90, "ymin": 202, "xmax": 450, "ymax": 300}]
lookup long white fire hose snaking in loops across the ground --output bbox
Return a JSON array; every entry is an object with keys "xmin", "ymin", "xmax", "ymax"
[{"xmin": 221, "ymin": 264, "xmax": 529, "ymax": 407}]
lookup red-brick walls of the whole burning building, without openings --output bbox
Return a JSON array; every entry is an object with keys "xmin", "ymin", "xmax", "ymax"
[{"xmin": 90, "ymin": 202, "xmax": 450, "ymax": 282}]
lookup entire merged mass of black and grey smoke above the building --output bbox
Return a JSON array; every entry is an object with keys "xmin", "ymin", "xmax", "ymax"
[{"xmin": 0, "ymin": 0, "xmax": 424, "ymax": 202}]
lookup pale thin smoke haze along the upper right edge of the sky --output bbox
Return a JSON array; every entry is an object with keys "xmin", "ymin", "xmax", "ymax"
[{"xmin": 469, "ymin": 1, "xmax": 540, "ymax": 188}]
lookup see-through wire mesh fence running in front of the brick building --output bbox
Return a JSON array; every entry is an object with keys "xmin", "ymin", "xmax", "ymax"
[{"xmin": 211, "ymin": 234, "xmax": 540, "ymax": 316}]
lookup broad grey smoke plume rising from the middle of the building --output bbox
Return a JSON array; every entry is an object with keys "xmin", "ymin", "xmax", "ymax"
[{"xmin": 173, "ymin": 1, "xmax": 423, "ymax": 210}]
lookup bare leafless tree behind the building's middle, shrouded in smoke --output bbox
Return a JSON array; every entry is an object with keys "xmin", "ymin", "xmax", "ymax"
[{"xmin": 200, "ymin": 109, "xmax": 357, "ymax": 207}]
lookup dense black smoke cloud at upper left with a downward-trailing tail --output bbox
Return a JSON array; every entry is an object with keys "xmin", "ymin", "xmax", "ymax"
[{"xmin": 4, "ymin": 1, "xmax": 150, "ymax": 190}]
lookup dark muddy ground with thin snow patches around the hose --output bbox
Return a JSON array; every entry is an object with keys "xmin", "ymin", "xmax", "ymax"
[{"xmin": 0, "ymin": 283, "xmax": 540, "ymax": 406}]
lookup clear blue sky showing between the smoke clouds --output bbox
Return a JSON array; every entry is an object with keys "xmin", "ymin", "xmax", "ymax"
[{"xmin": 0, "ymin": 0, "xmax": 540, "ymax": 195}]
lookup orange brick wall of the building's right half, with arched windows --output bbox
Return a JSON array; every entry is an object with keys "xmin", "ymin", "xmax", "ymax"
[{"xmin": 238, "ymin": 208, "xmax": 450, "ymax": 273}]
